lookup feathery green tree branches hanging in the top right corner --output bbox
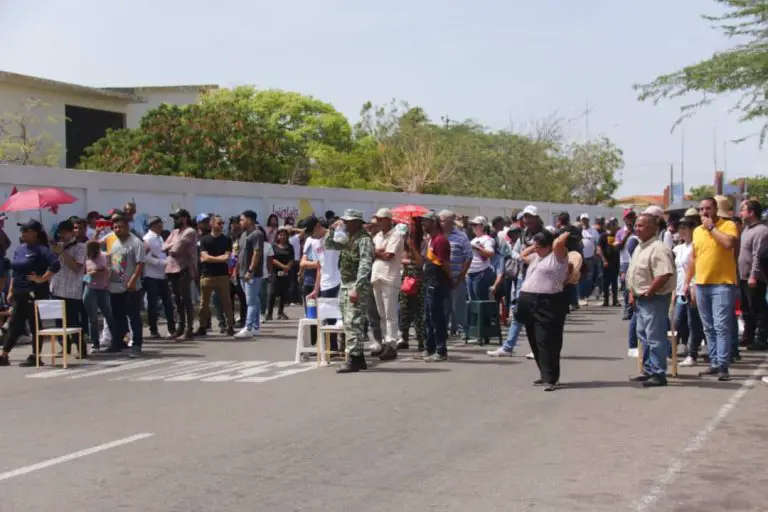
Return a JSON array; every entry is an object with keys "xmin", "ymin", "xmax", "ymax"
[{"xmin": 635, "ymin": 0, "xmax": 768, "ymax": 145}]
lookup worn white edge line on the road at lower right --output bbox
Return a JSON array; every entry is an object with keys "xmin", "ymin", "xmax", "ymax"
[{"xmin": 632, "ymin": 358, "xmax": 768, "ymax": 512}]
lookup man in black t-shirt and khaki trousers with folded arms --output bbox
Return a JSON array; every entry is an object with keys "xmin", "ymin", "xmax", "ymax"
[{"xmin": 196, "ymin": 215, "xmax": 235, "ymax": 336}]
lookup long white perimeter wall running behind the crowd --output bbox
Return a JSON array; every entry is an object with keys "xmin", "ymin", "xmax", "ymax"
[{"xmin": 0, "ymin": 165, "xmax": 621, "ymax": 239}]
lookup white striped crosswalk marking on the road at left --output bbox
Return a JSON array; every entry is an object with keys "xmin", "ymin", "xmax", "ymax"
[{"xmin": 26, "ymin": 357, "xmax": 318, "ymax": 384}]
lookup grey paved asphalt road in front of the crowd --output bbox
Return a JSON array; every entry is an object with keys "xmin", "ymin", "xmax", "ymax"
[{"xmin": 0, "ymin": 308, "xmax": 768, "ymax": 512}]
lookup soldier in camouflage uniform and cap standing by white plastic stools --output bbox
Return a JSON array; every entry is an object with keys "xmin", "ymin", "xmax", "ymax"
[{"xmin": 325, "ymin": 209, "xmax": 373, "ymax": 373}]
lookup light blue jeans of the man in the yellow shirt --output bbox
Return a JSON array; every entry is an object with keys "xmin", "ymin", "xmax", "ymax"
[{"xmin": 696, "ymin": 284, "xmax": 736, "ymax": 371}]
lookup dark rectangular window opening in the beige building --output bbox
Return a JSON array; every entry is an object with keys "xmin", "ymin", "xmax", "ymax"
[{"xmin": 64, "ymin": 105, "xmax": 125, "ymax": 169}]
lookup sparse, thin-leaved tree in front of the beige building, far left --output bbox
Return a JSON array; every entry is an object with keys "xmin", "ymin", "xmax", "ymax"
[{"xmin": 0, "ymin": 98, "xmax": 64, "ymax": 167}]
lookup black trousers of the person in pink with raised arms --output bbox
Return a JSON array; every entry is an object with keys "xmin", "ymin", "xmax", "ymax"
[{"xmin": 515, "ymin": 292, "xmax": 568, "ymax": 384}]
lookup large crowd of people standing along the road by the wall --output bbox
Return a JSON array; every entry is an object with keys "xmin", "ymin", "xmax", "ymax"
[{"xmin": 0, "ymin": 197, "xmax": 768, "ymax": 390}]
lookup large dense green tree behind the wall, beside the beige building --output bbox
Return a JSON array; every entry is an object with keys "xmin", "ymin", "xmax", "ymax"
[{"xmin": 79, "ymin": 87, "xmax": 352, "ymax": 185}]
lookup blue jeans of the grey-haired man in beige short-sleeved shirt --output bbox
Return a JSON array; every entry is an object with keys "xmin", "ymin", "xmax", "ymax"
[{"xmin": 633, "ymin": 295, "xmax": 671, "ymax": 377}]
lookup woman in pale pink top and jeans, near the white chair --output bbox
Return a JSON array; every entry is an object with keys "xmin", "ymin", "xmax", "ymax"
[{"xmin": 83, "ymin": 240, "xmax": 114, "ymax": 351}]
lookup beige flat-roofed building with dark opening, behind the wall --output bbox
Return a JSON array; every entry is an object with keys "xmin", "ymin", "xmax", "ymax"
[{"xmin": 0, "ymin": 71, "xmax": 218, "ymax": 168}]
